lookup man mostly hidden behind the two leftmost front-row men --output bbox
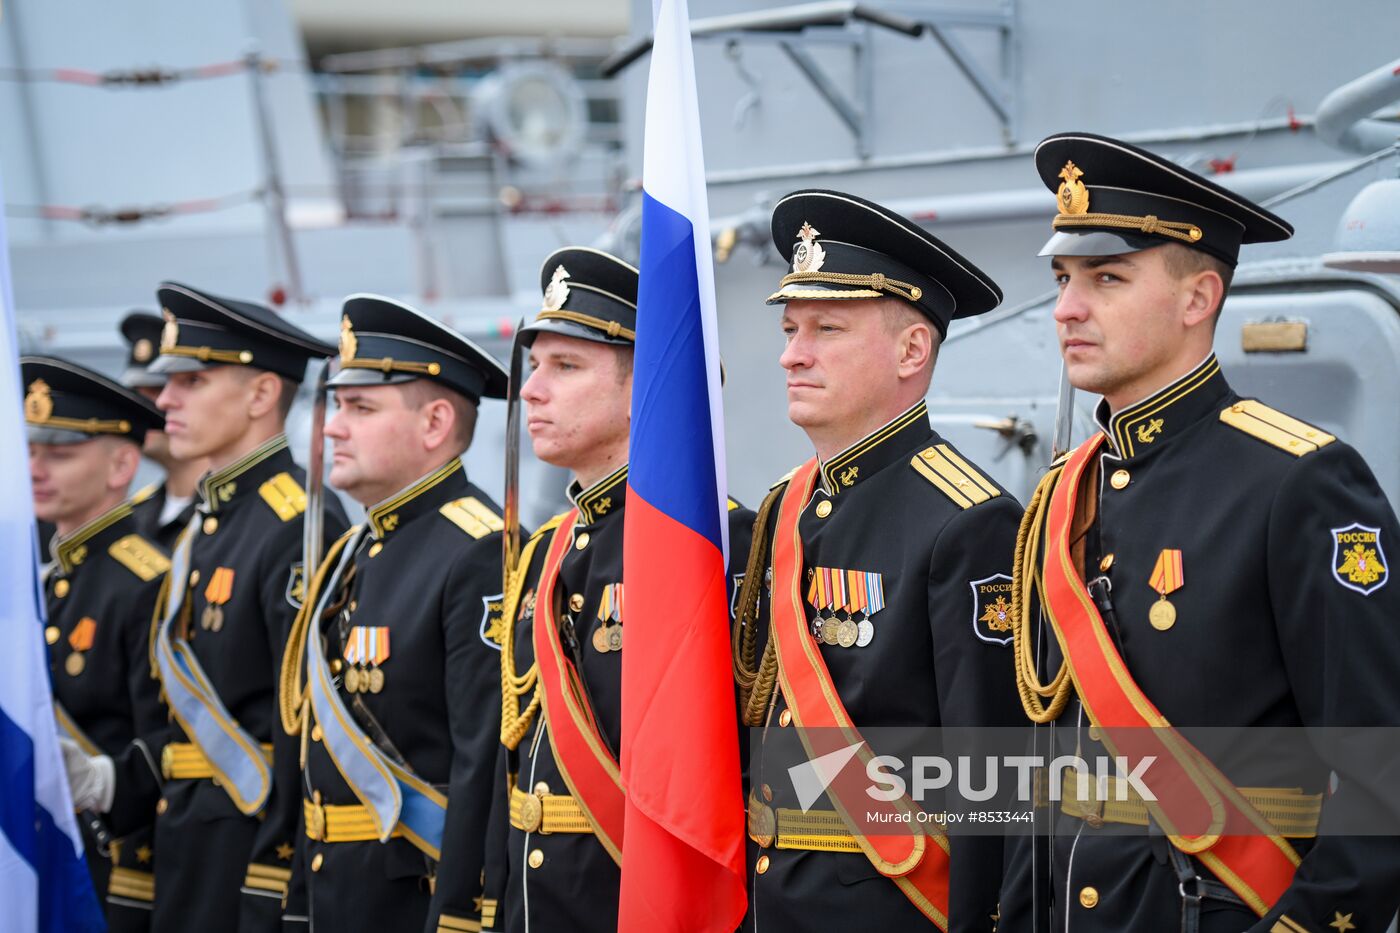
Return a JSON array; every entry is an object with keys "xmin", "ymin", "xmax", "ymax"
[{"xmin": 120, "ymin": 311, "xmax": 209, "ymax": 552}]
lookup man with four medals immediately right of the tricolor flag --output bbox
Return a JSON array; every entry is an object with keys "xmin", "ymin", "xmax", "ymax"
[{"xmin": 735, "ymin": 191, "xmax": 1021, "ymax": 932}]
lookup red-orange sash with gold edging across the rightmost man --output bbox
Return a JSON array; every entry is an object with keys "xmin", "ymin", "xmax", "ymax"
[{"xmin": 1042, "ymin": 434, "xmax": 1299, "ymax": 916}]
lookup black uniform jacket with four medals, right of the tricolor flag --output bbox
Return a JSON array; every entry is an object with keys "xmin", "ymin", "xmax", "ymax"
[{"xmin": 745, "ymin": 402, "xmax": 1021, "ymax": 933}]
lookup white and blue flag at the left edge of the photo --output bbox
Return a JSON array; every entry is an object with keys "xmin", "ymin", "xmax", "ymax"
[{"xmin": 0, "ymin": 163, "xmax": 106, "ymax": 933}]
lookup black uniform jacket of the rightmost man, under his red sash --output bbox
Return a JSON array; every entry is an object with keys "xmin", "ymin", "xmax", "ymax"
[{"xmin": 1002, "ymin": 354, "xmax": 1400, "ymax": 933}]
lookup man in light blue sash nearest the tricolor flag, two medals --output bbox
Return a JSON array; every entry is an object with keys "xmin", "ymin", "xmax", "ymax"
[{"xmin": 283, "ymin": 296, "xmax": 507, "ymax": 933}]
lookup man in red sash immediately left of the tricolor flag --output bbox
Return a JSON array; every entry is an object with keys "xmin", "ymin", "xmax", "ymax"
[{"xmin": 483, "ymin": 247, "xmax": 753, "ymax": 933}]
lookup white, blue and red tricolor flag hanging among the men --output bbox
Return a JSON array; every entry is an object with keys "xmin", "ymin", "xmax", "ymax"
[{"xmin": 617, "ymin": 0, "xmax": 746, "ymax": 933}]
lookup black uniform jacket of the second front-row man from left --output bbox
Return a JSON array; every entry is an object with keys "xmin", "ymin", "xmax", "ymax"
[{"xmin": 111, "ymin": 434, "xmax": 346, "ymax": 933}]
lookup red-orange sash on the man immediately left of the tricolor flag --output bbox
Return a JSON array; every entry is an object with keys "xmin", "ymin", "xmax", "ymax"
[{"xmin": 533, "ymin": 509, "xmax": 626, "ymax": 864}]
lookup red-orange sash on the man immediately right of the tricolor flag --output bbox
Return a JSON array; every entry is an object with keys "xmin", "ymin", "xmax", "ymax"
[{"xmin": 773, "ymin": 458, "xmax": 948, "ymax": 930}]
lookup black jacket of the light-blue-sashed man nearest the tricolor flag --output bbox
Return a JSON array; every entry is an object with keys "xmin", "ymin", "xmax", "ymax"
[{"xmin": 298, "ymin": 458, "xmax": 503, "ymax": 933}]
